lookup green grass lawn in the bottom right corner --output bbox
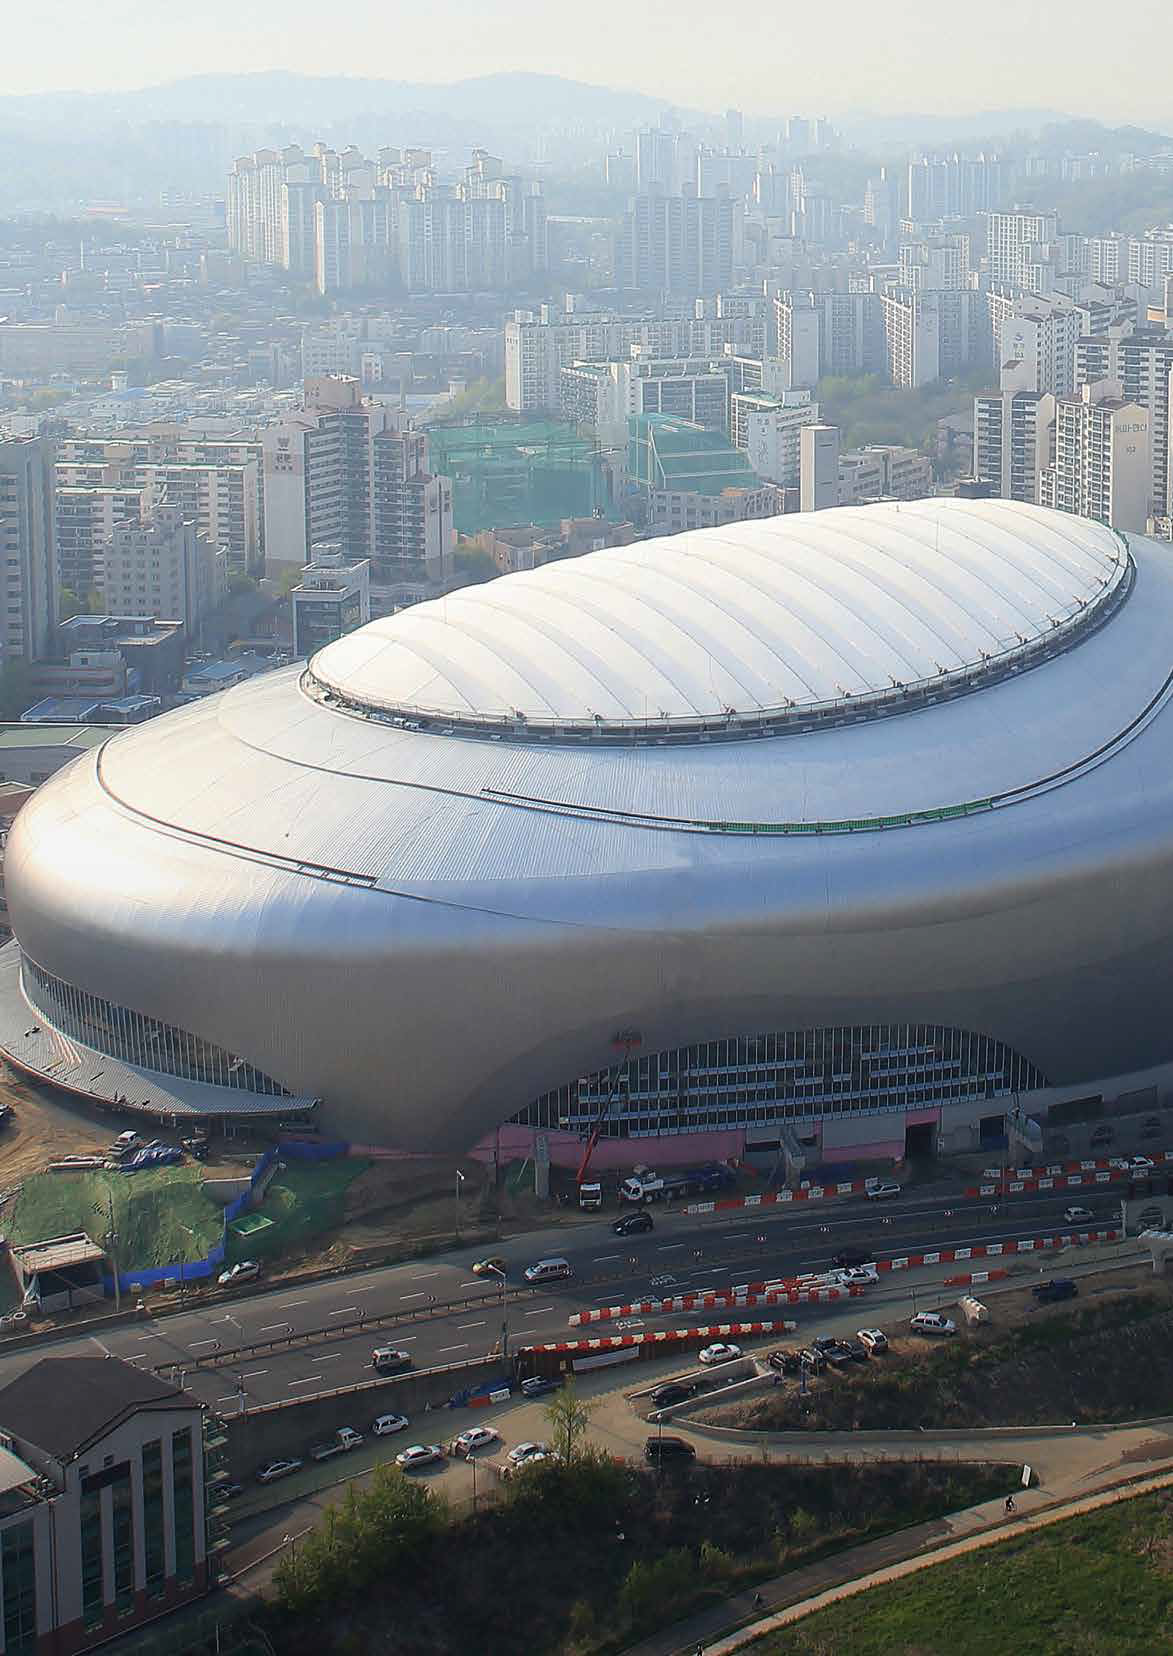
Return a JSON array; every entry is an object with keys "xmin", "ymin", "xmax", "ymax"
[{"xmin": 752, "ymin": 1492, "xmax": 1173, "ymax": 1656}]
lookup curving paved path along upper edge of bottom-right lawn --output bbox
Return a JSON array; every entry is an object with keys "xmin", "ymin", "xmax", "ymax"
[{"xmin": 625, "ymin": 1471, "xmax": 1173, "ymax": 1656}]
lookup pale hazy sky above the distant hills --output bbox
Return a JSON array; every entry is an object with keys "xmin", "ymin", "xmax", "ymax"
[{"xmin": 0, "ymin": 0, "xmax": 1173, "ymax": 124}]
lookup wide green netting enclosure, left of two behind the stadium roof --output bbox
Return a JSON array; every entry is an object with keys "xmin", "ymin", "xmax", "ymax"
[{"xmin": 427, "ymin": 416, "xmax": 618, "ymax": 535}]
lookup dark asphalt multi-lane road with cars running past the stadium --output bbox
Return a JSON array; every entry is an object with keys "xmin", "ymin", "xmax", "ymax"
[{"xmin": 0, "ymin": 1189, "xmax": 1120, "ymax": 1409}]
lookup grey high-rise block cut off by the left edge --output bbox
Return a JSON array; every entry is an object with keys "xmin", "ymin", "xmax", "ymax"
[{"xmin": 0, "ymin": 437, "xmax": 56, "ymax": 664}]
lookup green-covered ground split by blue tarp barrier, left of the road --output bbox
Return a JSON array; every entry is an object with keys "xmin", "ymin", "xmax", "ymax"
[{"xmin": 5, "ymin": 1167, "xmax": 222, "ymax": 1270}]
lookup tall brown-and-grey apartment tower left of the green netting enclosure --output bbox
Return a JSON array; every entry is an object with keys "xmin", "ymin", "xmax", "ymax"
[{"xmin": 263, "ymin": 378, "xmax": 454, "ymax": 585}]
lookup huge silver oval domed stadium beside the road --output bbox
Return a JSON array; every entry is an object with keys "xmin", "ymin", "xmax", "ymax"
[{"xmin": 0, "ymin": 500, "xmax": 1173, "ymax": 1166}]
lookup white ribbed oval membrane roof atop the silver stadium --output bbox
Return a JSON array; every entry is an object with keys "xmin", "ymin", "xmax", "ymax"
[{"xmin": 307, "ymin": 500, "xmax": 1130, "ymax": 730}]
